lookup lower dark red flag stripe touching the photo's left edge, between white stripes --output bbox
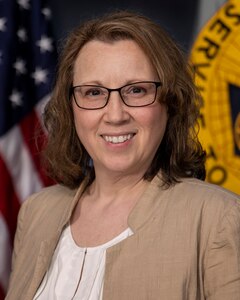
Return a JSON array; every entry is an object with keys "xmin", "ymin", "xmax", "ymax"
[{"xmin": 0, "ymin": 156, "xmax": 20, "ymax": 243}]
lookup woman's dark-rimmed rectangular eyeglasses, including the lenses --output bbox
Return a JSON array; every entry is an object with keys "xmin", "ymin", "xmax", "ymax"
[{"xmin": 70, "ymin": 81, "xmax": 161, "ymax": 110}]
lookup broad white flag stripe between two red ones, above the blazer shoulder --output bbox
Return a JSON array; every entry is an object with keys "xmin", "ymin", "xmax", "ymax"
[{"xmin": 0, "ymin": 126, "xmax": 43, "ymax": 202}]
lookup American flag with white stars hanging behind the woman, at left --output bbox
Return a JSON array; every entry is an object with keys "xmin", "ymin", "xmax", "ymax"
[{"xmin": 0, "ymin": 0, "xmax": 56, "ymax": 300}]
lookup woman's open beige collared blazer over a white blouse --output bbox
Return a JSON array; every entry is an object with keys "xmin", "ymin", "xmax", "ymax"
[{"xmin": 6, "ymin": 176, "xmax": 240, "ymax": 300}]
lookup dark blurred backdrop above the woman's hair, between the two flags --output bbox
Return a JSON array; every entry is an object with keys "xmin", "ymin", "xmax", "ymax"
[{"xmin": 47, "ymin": 0, "xmax": 199, "ymax": 49}]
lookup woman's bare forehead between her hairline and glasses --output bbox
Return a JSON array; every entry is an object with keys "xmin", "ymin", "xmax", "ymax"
[{"xmin": 74, "ymin": 40, "xmax": 155, "ymax": 84}]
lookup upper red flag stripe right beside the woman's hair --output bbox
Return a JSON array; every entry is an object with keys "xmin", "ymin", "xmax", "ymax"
[{"xmin": 19, "ymin": 111, "xmax": 53, "ymax": 186}]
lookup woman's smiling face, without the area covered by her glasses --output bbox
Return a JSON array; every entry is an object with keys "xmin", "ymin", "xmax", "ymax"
[{"xmin": 72, "ymin": 40, "xmax": 167, "ymax": 176}]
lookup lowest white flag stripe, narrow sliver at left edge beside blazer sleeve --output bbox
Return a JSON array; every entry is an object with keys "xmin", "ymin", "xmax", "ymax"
[{"xmin": 0, "ymin": 213, "xmax": 12, "ymax": 292}]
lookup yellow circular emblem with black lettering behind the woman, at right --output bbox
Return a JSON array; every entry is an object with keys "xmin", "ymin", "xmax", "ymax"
[{"xmin": 190, "ymin": 0, "xmax": 240, "ymax": 194}]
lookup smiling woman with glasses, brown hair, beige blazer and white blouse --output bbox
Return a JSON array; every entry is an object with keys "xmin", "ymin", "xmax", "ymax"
[{"xmin": 6, "ymin": 12, "xmax": 240, "ymax": 300}]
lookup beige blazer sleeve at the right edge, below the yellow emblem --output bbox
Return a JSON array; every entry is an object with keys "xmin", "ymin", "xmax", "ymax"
[{"xmin": 204, "ymin": 201, "xmax": 240, "ymax": 300}]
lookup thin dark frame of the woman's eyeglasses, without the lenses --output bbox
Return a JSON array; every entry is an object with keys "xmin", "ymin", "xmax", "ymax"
[{"xmin": 69, "ymin": 81, "xmax": 162, "ymax": 110}]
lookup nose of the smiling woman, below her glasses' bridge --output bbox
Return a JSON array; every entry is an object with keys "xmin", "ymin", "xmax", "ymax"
[{"xmin": 104, "ymin": 91, "xmax": 130, "ymax": 124}]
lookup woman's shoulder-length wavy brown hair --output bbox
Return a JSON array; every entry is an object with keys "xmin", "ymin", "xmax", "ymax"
[{"xmin": 44, "ymin": 11, "xmax": 205, "ymax": 188}]
